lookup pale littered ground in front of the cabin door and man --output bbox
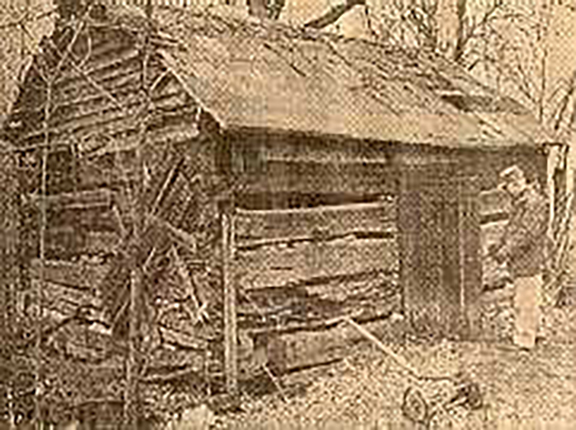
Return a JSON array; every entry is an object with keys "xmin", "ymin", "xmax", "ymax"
[{"xmin": 214, "ymin": 249, "xmax": 576, "ymax": 429}]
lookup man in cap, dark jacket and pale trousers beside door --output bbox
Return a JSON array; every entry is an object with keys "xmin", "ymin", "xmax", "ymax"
[{"xmin": 489, "ymin": 166, "xmax": 548, "ymax": 349}]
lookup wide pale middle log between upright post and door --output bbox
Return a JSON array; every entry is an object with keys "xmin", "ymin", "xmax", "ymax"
[{"xmin": 236, "ymin": 237, "xmax": 398, "ymax": 290}]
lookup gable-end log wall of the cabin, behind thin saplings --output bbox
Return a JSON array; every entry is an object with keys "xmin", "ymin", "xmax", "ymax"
[{"xmin": 6, "ymin": 17, "xmax": 222, "ymax": 394}]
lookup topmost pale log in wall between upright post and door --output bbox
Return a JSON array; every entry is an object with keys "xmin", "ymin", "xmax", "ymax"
[{"xmin": 236, "ymin": 201, "xmax": 395, "ymax": 247}]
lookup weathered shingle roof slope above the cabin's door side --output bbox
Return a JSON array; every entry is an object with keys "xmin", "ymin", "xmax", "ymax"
[{"xmin": 146, "ymin": 5, "xmax": 547, "ymax": 147}]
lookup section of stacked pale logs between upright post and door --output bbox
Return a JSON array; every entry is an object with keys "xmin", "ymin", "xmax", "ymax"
[{"xmin": 236, "ymin": 199, "xmax": 400, "ymax": 333}]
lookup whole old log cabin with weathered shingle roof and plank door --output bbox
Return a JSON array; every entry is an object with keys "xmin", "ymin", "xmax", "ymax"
[{"xmin": 3, "ymin": 2, "xmax": 565, "ymax": 404}]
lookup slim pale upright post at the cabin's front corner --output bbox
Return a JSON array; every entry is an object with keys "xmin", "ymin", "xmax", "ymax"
[{"xmin": 220, "ymin": 202, "xmax": 238, "ymax": 395}]
